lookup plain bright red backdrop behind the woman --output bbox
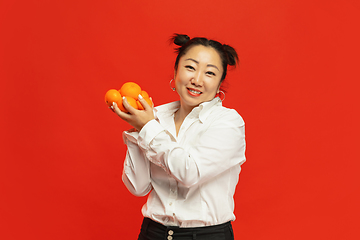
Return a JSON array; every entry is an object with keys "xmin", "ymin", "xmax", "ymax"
[{"xmin": 0, "ymin": 0, "xmax": 360, "ymax": 240}]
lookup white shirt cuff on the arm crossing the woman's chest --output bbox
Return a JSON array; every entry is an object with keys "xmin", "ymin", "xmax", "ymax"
[{"xmin": 138, "ymin": 119, "xmax": 164, "ymax": 149}]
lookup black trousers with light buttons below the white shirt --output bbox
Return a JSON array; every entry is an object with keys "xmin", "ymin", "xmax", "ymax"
[{"xmin": 138, "ymin": 218, "xmax": 234, "ymax": 240}]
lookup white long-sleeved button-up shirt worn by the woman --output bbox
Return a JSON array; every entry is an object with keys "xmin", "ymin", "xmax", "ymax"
[{"xmin": 123, "ymin": 98, "xmax": 245, "ymax": 227}]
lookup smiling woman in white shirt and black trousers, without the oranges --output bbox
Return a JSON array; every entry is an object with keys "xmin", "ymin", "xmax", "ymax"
[{"xmin": 113, "ymin": 34, "xmax": 245, "ymax": 240}]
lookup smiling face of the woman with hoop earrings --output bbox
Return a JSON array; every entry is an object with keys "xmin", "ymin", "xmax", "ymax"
[{"xmin": 175, "ymin": 45, "xmax": 223, "ymax": 110}]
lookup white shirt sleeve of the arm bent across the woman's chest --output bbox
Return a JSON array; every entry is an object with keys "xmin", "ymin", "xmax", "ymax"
[{"xmin": 138, "ymin": 110, "xmax": 245, "ymax": 187}]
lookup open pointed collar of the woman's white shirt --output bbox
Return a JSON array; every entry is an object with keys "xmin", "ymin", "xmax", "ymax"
[{"xmin": 154, "ymin": 97, "xmax": 222, "ymax": 123}]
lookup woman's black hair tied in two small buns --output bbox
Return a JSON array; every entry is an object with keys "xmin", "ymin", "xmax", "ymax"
[{"xmin": 170, "ymin": 34, "xmax": 239, "ymax": 82}]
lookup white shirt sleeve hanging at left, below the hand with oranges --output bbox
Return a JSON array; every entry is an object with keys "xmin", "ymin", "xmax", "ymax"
[{"xmin": 122, "ymin": 132, "xmax": 152, "ymax": 196}]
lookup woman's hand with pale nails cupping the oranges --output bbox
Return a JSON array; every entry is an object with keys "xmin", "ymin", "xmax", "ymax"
[{"xmin": 112, "ymin": 95, "xmax": 155, "ymax": 131}]
